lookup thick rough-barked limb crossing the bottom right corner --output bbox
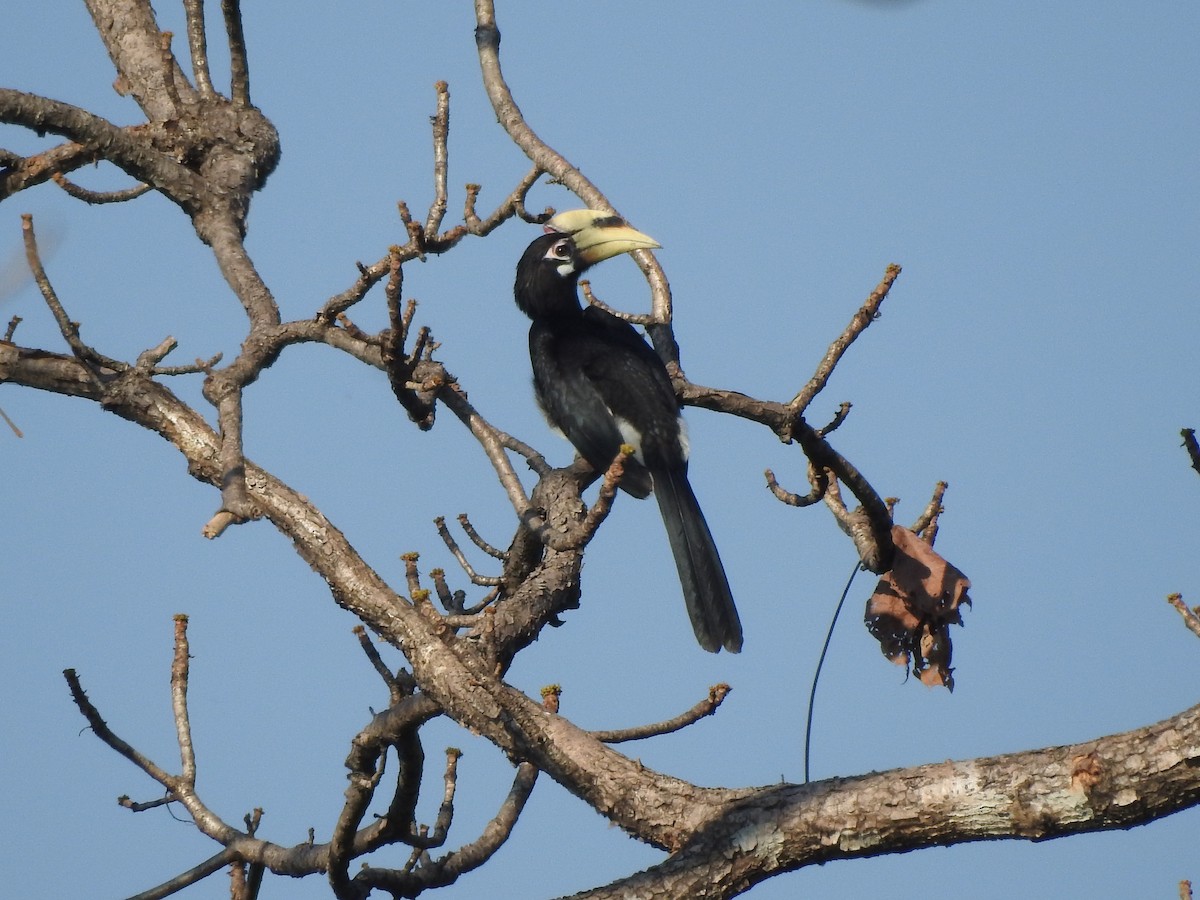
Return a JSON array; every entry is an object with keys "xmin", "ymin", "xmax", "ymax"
[{"xmin": 576, "ymin": 707, "xmax": 1200, "ymax": 900}]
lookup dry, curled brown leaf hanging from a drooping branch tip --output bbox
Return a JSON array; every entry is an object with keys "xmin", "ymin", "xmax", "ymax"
[{"xmin": 865, "ymin": 526, "xmax": 971, "ymax": 690}]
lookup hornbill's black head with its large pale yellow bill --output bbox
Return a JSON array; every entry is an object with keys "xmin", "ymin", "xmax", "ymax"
[{"xmin": 514, "ymin": 209, "xmax": 659, "ymax": 319}]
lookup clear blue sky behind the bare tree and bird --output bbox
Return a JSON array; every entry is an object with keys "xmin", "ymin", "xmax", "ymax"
[{"xmin": 0, "ymin": 0, "xmax": 1200, "ymax": 900}]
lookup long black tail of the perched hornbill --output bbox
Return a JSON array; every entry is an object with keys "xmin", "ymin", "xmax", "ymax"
[{"xmin": 654, "ymin": 469, "xmax": 742, "ymax": 653}]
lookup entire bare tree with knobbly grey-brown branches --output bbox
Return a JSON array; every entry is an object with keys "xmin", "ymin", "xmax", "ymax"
[{"xmin": 0, "ymin": 0, "xmax": 1200, "ymax": 900}]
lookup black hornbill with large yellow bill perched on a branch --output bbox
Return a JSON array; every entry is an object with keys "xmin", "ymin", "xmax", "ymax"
[{"xmin": 514, "ymin": 210, "xmax": 742, "ymax": 653}]
